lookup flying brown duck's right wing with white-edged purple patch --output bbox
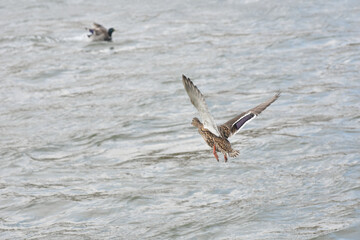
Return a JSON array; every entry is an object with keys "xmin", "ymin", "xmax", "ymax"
[{"xmin": 219, "ymin": 92, "xmax": 280, "ymax": 138}]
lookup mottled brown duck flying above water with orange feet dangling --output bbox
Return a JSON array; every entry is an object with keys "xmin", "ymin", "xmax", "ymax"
[{"xmin": 182, "ymin": 75, "xmax": 280, "ymax": 162}]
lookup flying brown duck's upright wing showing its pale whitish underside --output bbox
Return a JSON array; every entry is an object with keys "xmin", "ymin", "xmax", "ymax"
[{"xmin": 182, "ymin": 75, "xmax": 220, "ymax": 136}]
